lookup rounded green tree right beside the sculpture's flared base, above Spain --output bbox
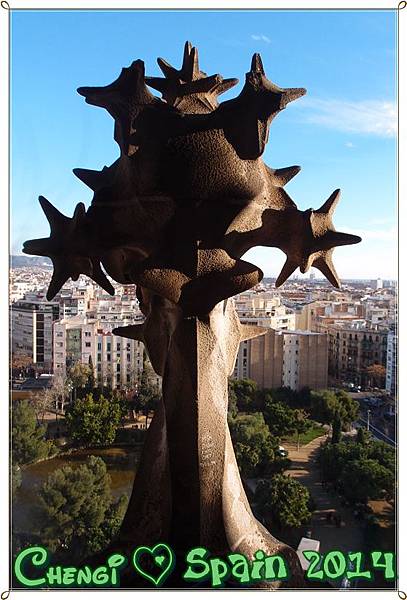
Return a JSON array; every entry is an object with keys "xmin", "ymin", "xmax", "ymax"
[{"xmin": 254, "ymin": 474, "xmax": 311, "ymax": 529}]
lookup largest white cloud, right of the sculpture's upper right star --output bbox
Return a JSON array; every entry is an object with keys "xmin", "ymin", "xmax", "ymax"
[{"xmin": 297, "ymin": 98, "xmax": 397, "ymax": 137}]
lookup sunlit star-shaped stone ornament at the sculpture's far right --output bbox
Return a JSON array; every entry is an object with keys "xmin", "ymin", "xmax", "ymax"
[{"xmin": 276, "ymin": 190, "xmax": 361, "ymax": 287}]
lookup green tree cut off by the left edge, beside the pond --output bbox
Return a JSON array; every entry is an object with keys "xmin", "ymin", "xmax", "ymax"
[{"xmin": 11, "ymin": 400, "xmax": 53, "ymax": 465}]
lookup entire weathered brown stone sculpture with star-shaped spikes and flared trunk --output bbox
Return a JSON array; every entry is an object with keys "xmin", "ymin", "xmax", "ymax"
[{"xmin": 24, "ymin": 42, "xmax": 360, "ymax": 587}]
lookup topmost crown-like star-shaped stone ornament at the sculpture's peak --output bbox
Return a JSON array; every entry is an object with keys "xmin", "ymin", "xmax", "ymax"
[{"xmin": 146, "ymin": 42, "xmax": 238, "ymax": 114}]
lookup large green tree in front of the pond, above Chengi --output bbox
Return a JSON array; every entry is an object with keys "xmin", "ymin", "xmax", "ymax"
[{"xmin": 39, "ymin": 456, "xmax": 127, "ymax": 558}]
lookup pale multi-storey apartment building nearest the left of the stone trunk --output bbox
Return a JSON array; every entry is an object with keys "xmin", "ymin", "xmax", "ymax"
[{"xmin": 54, "ymin": 315, "xmax": 144, "ymax": 388}]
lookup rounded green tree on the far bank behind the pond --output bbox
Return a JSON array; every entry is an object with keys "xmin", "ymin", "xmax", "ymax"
[{"xmin": 65, "ymin": 394, "xmax": 123, "ymax": 446}]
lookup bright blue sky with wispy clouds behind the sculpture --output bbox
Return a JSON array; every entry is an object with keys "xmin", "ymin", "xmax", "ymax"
[{"xmin": 11, "ymin": 11, "xmax": 397, "ymax": 278}]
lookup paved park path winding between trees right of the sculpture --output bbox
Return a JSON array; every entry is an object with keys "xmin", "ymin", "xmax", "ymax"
[{"xmin": 285, "ymin": 436, "xmax": 363, "ymax": 554}]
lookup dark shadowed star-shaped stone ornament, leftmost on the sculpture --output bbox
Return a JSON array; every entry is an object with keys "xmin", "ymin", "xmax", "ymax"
[{"xmin": 23, "ymin": 196, "xmax": 114, "ymax": 300}]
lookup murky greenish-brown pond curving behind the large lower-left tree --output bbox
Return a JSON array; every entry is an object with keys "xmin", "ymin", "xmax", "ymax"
[{"xmin": 12, "ymin": 447, "xmax": 140, "ymax": 534}]
